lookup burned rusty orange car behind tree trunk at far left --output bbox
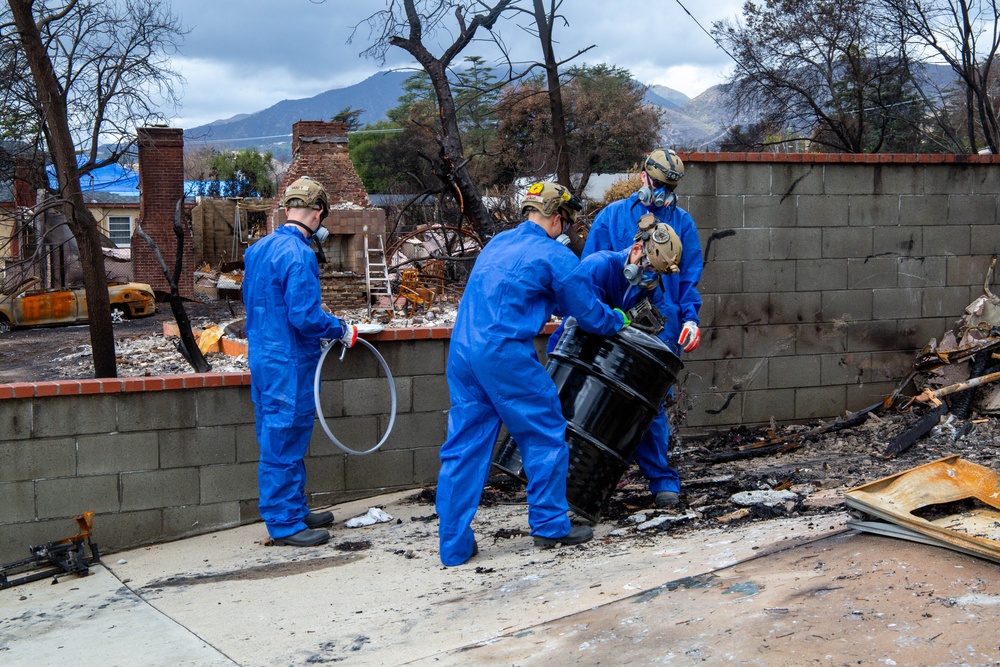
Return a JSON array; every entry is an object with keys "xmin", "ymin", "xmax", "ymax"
[{"xmin": 0, "ymin": 278, "xmax": 156, "ymax": 331}]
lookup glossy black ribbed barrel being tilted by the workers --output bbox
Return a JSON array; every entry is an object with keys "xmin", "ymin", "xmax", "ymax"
[{"xmin": 493, "ymin": 318, "xmax": 683, "ymax": 521}]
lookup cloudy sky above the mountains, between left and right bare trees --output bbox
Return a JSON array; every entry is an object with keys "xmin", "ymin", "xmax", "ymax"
[{"xmin": 171, "ymin": 0, "xmax": 742, "ymax": 128}]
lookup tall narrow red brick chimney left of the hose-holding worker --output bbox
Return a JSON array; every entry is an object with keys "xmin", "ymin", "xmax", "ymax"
[{"xmin": 132, "ymin": 127, "xmax": 194, "ymax": 297}]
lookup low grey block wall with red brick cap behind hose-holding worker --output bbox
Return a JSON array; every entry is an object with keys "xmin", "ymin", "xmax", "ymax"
[{"xmin": 0, "ymin": 328, "xmax": 450, "ymax": 562}]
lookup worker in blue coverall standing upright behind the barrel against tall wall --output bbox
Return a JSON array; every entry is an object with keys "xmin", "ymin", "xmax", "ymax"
[{"xmin": 583, "ymin": 149, "xmax": 704, "ymax": 507}]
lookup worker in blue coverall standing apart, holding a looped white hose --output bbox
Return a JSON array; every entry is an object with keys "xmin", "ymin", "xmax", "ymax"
[{"xmin": 243, "ymin": 176, "xmax": 358, "ymax": 547}]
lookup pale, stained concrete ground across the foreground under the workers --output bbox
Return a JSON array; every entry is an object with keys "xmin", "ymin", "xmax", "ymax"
[{"xmin": 0, "ymin": 492, "xmax": 1000, "ymax": 667}]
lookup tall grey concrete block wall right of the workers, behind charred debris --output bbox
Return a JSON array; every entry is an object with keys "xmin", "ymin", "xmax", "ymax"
[{"xmin": 678, "ymin": 153, "xmax": 1000, "ymax": 432}]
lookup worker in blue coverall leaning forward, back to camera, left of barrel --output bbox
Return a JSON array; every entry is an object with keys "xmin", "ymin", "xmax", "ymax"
[{"xmin": 437, "ymin": 183, "xmax": 628, "ymax": 566}]
